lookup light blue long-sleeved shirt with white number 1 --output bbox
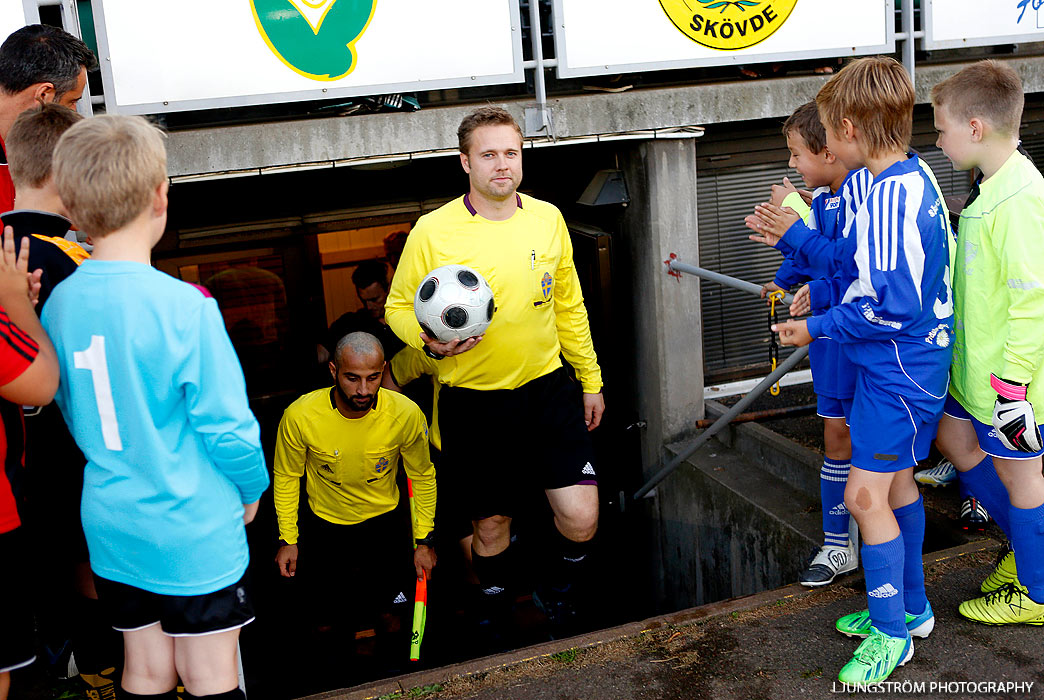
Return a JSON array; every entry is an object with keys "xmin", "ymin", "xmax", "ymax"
[{"xmin": 43, "ymin": 260, "xmax": 268, "ymax": 596}]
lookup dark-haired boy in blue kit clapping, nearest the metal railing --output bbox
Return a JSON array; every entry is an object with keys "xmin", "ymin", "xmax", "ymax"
[{"xmin": 745, "ymin": 100, "xmax": 869, "ymax": 587}]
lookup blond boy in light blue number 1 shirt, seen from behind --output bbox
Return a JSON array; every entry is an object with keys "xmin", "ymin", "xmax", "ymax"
[{"xmin": 43, "ymin": 115, "xmax": 268, "ymax": 700}]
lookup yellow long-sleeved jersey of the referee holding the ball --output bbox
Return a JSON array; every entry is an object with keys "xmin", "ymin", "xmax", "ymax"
[{"xmin": 384, "ymin": 194, "xmax": 601, "ymax": 394}]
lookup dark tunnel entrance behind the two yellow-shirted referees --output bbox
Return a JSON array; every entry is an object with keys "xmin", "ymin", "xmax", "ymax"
[{"xmin": 153, "ymin": 142, "xmax": 663, "ymax": 697}]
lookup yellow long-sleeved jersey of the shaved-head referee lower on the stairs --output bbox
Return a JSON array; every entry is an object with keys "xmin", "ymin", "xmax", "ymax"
[{"xmin": 272, "ymin": 389, "xmax": 435, "ymax": 544}]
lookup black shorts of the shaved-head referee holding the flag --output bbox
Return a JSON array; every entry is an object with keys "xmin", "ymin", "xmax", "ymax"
[{"xmin": 294, "ymin": 505, "xmax": 417, "ymax": 628}]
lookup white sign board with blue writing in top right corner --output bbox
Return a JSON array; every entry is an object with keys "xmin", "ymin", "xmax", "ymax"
[{"xmin": 922, "ymin": 0, "xmax": 1044, "ymax": 49}]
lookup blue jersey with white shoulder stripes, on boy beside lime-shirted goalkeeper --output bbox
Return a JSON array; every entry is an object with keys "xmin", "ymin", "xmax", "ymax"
[{"xmin": 808, "ymin": 155, "xmax": 953, "ymax": 402}]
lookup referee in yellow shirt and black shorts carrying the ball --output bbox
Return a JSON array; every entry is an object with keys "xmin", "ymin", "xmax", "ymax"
[{"xmin": 385, "ymin": 107, "xmax": 604, "ymax": 631}]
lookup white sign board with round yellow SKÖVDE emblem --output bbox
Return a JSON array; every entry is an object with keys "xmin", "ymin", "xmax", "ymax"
[{"xmin": 554, "ymin": 0, "xmax": 895, "ymax": 77}]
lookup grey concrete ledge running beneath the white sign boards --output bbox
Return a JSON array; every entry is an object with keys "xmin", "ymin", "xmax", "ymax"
[{"xmin": 168, "ymin": 57, "xmax": 1044, "ymax": 177}]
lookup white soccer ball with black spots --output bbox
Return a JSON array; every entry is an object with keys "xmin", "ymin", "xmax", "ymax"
[{"xmin": 413, "ymin": 265, "xmax": 496, "ymax": 343}]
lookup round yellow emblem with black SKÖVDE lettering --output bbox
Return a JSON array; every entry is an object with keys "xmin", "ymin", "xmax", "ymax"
[{"xmin": 660, "ymin": 0, "xmax": 798, "ymax": 51}]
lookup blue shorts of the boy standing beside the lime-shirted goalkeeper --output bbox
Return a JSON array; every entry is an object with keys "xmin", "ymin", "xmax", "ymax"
[{"xmin": 849, "ymin": 375, "xmax": 943, "ymax": 472}]
